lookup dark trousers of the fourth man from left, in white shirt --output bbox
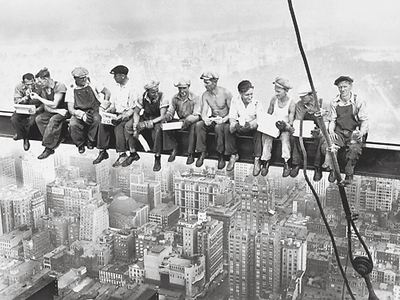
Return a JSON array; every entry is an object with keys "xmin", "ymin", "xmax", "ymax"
[{"xmin": 97, "ymin": 121, "xmax": 128, "ymax": 152}]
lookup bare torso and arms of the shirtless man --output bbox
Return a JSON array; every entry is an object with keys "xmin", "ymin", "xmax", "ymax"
[{"xmin": 201, "ymin": 86, "xmax": 232, "ymax": 118}]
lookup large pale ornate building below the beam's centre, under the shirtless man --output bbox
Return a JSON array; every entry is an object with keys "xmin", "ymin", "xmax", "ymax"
[{"xmin": 174, "ymin": 171, "xmax": 234, "ymax": 220}]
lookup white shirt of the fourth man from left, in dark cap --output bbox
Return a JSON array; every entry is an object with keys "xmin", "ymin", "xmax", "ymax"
[{"xmin": 110, "ymin": 81, "xmax": 140, "ymax": 113}]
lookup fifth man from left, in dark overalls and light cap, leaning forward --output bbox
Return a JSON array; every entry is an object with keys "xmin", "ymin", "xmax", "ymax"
[{"xmin": 122, "ymin": 80, "xmax": 169, "ymax": 172}]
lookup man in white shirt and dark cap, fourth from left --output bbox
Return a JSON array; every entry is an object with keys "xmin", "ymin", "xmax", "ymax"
[{"xmin": 93, "ymin": 65, "xmax": 139, "ymax": 167}]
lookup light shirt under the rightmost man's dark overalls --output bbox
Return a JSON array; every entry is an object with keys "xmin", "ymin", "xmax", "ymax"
[{"xmin": 329, "ymin": 93, "xmax": 369, "ymax": 133}]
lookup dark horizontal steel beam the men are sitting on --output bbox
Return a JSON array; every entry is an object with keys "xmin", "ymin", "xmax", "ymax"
[{"xmin": 0, "ymin": 111, "xmax": 400, "ymax": 179}]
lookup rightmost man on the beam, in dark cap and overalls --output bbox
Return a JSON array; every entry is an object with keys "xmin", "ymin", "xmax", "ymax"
[{"xmin": 328, "ymin": 76, "xmax": 368, "ymax": 184}]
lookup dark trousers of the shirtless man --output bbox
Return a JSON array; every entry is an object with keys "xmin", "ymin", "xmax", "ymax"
[{"xmin": 196, "ymin": 121, "xmax": 237, "ymax": 155}]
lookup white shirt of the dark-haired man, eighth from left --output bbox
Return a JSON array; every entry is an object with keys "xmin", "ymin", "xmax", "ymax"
[{"xmin": 229, "ymin": 96, "xmax": 262, "ymax": 125}]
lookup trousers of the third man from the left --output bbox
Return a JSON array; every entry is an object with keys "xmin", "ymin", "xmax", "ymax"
[{"xmin": 69, "ymin": 112, "xmax": 101, "ymax": 147}]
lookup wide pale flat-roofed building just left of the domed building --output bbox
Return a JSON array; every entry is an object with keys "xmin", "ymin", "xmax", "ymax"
[{"xmin": 47, "ymin": 177, "xmax": 100, "ymax": 214}]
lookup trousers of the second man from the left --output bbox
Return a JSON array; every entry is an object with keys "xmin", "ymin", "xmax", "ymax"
[{"xmin": 35, "ymin": 111, "xmax": 68, "ymax": 149}]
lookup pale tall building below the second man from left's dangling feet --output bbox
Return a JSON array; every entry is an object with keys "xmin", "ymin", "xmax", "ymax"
[{"xmin": 22, "ymin": 154, "xmax": 56, "ymax": 195}]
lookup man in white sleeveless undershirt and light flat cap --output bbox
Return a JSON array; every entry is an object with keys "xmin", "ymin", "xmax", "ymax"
[{"xmin": 261, "ymin": 77, "xmax": 295, "ymax": 177}]
